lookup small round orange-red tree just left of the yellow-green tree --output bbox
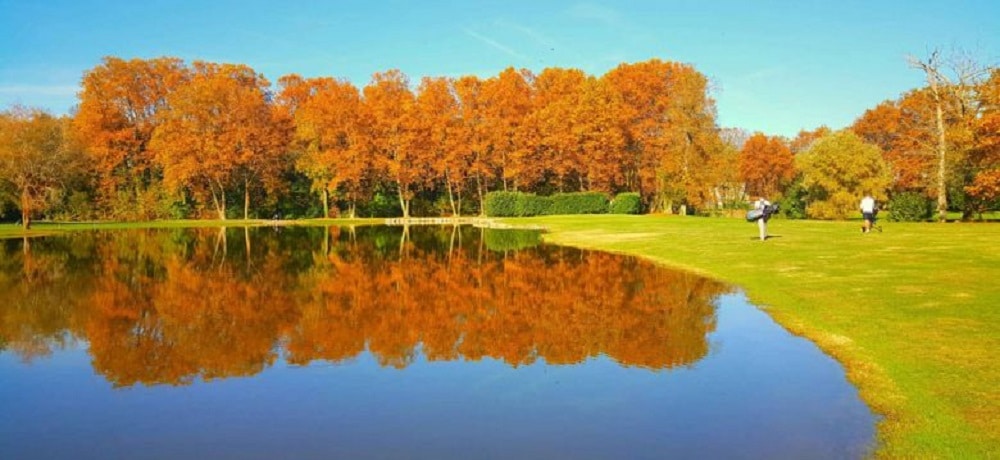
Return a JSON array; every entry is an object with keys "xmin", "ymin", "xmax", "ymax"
[{"xmin": 738, "ymin": 133, "xmax": 795, "ymax": 197}]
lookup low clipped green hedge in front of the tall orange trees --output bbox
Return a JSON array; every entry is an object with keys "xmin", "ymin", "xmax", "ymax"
[{"xmin": 485, "ymin": 192, "xmax": 641, "ymax": 217}]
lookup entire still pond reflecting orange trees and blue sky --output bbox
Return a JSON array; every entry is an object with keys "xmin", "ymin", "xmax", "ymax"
[{"xmin": 0, "ymin": 227, "xmax": 874, "ymax": 459}]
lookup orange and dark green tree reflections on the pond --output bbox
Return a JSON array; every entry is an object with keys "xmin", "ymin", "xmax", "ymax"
[{"xmin": 0, "ymin": 227, "xmax": 725, "ymax": 386}]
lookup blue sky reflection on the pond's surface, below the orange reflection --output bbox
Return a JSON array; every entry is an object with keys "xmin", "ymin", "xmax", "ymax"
[{"xmin": 0, "ymin": 295, "xmax": 874, "ymax": 458}]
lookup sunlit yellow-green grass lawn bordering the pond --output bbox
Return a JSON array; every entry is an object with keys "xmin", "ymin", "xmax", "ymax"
[{"xmin": 0, "ymin": 216, "xmax": 1000, "ymax": 458}]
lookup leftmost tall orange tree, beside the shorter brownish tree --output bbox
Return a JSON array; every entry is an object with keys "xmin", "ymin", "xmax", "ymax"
[{"xmin": 73, "ymin": 57, "xmax": 189, "ymax": 218}]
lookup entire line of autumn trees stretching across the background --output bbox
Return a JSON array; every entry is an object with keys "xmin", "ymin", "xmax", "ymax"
[{"xmin": 0, "ymin": 54, "xmax": 1000, "ymax": 225}]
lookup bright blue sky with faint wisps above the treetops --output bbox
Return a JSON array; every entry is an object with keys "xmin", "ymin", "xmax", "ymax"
[{"xmin": 0, "ymin": 0, "xmax": 1000, "ymax": 136}]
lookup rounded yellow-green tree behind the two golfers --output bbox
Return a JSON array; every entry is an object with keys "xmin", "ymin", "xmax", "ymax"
[{"xmin": 795, "ymin": 130, "xmax": 891, "ymax": 219}]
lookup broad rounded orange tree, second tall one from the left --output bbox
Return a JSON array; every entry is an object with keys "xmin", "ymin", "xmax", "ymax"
[{"xmin": 151, "ymin": 62, "xmax": 290, "ymax": 219}]
